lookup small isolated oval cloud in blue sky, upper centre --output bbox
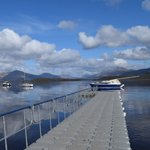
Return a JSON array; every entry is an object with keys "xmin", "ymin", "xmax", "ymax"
[{"xmin": 58, "ymin": 20, "xmax": 76, "ymax": 30}]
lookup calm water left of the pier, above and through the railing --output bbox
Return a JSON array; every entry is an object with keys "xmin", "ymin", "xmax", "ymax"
[{"xmin": 0, "ymin": 82, "xmax": 89, "ymax": 150}]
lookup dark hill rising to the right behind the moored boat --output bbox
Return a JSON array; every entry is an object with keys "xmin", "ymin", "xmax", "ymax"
[{"xmin": 81, "ymin": 68, "xmax": 150, "ymax": 86}]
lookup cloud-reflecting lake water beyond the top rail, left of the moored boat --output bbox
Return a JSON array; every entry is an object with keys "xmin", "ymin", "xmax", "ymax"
[{"xmin": 0, "ymin": 81, "xmax": 88, "ymax": 113}]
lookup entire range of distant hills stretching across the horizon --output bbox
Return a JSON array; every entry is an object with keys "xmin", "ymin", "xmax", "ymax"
[{"xmin": 1, "ymin": 68, "xmax": 150, "ymax": 83}]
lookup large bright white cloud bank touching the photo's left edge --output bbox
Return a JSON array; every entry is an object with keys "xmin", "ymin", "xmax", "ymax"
[{"xmin": 0, "ymin": 29, "xmax": 55, "ymax": 70}]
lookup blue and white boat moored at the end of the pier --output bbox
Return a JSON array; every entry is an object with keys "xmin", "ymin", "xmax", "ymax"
[{"xmin": 90, "ymin": 79, "xmax": 124, "ymax": 90}]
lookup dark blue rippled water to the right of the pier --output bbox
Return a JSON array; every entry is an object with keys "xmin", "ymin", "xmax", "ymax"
[{"xmin": 123, "ymin": 86, "xmax": 150, "ymax": 150}]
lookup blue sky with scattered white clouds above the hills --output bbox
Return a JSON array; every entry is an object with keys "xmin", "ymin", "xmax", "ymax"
[{"xmin": 0, "ymin": 0, "xmax": 150, "ymax": 76}]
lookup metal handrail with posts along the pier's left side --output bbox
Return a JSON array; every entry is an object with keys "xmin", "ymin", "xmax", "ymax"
[{"xmin": 0, "ymin": 88, "xmax": 89, "ymax": 150}]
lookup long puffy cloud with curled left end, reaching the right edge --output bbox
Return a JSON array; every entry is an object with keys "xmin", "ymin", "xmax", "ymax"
[{"xmin": 79, "ymin": 25, "xmax": 150, "ymax": 49}]
